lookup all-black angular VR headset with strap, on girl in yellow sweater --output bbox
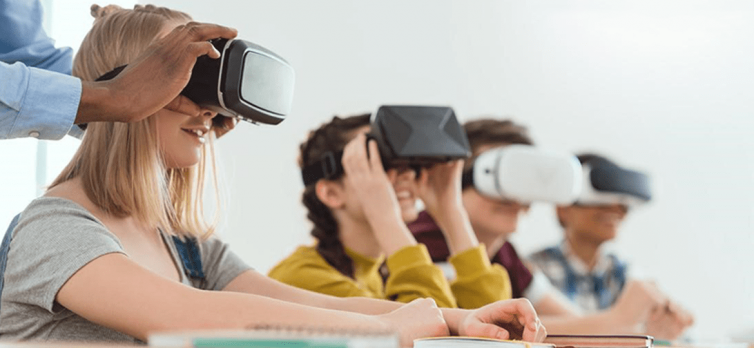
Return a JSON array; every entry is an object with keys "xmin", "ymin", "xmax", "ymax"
[{"xmin": 301, "ymin": 106, "xmax": 471, "ymax": 186}]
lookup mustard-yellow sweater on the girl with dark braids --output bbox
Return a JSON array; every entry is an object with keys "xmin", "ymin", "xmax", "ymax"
[{"xmin": 269, "ymin": 244, "xmax": 511, "ymax": 308}]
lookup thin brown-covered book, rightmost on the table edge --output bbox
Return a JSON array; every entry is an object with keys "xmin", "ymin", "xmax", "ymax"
[{"xmin": 545, "ymin": 335, "xmax": 653, "ymax": 348}]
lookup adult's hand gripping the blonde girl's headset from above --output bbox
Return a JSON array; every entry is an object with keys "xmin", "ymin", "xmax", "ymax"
[{"xmin": 75, "ymin": 22, "xmax": 237, "ymax": 124}]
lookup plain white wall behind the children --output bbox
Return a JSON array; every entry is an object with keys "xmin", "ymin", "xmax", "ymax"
[{"xmin": 0, "ymin": 0, "xmax": 754, "ymax": 337}]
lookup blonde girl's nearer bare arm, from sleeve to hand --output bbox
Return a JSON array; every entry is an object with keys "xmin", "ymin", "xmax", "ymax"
[{"xmin": 56, "ymin": 253, "xmax": 447, "ymax": 343}]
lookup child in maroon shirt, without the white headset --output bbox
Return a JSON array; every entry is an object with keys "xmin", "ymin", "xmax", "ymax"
[{"xmin": 409, "ymin": 118, "xmax": 692, "ymax": 338}]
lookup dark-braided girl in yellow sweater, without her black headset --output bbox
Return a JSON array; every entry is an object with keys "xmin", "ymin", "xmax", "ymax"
[{"xmin": 269, "ymin": 114, "xmax": 524, "ymax": 308}]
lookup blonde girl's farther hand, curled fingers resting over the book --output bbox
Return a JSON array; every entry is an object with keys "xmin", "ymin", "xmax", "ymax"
[{"xmin": 458, "ymin": 299, "xmax": 547, "ymax": 342}]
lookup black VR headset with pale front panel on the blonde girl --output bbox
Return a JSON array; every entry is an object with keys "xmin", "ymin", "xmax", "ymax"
[{"xmin": 97, "ymin": 39, "xmax": 295, "ymax": 125}]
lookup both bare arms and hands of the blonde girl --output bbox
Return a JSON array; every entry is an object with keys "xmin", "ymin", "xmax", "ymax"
[{"xmin": 56, "ymin": 253, "xmax": 544, "ymax": 346}]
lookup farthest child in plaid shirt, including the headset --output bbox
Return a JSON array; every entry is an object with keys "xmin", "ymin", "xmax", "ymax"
[{"xmin": 530, "ymin": 154, "xmax": 693, "ymax": 338}]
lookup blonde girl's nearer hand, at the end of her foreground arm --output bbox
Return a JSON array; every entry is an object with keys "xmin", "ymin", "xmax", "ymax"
[{"xmin": 379, "ymin": 298, "xmax": 449, "ymax": 347}]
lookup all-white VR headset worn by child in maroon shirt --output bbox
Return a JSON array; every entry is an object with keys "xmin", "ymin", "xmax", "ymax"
[{"xmin": 463, "ymin": 145, "xmax": 583, "ymax": 204}]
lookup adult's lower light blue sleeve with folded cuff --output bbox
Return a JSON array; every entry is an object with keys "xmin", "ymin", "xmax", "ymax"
[{"xmin": 0, "ymin": 62, "xmax": 82, "ymax": 140}]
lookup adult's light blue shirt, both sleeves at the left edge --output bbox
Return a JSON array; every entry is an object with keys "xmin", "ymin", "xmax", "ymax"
[{"xmin": 0, "ymin": 0, "xmax": 83, "ymax": 139}]
